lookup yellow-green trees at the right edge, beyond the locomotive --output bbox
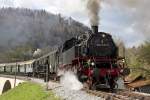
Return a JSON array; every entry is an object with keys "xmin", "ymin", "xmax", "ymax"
[{"xmin": 127, "ymin": 42, "xmax": 150, "ymax": 78}]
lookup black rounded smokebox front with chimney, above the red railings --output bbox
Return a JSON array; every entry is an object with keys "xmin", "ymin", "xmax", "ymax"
[{"xmin": 87, "ymin": 26, "xmax": 118, "ymax": 58}]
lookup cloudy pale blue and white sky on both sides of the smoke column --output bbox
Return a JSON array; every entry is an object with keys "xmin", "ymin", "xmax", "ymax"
[{"xmin": 0, "ymin": 0, "xmax": 150, "ymax": 47}]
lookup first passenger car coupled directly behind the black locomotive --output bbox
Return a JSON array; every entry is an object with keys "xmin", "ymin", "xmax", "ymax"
[{"xmin": 33, "ymin": 50, "xmax": 58, "ymax": 81}]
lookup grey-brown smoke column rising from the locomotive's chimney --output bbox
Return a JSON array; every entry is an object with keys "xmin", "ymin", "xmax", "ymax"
[{"xmin": 87, "ymin": 0, "xmax": 101, "ymax": 26}]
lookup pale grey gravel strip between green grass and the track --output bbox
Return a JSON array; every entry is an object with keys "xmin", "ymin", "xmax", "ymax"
[{"xmin": 48, "ymin": 82, "xmax": 104, "ymax": 100}]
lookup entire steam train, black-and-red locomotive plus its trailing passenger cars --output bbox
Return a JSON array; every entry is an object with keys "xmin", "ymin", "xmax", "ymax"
[{"xmin": 1, "ymin": 26, "xmax": 124, "ymax": 89}]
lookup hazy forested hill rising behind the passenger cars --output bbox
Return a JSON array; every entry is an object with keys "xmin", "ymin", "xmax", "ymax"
[{"xmin": 0, "ymin": 8, "xmax": 88, "ymax": 62}]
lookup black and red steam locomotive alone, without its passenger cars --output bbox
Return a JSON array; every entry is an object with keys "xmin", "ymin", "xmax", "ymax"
[{"xmin": 59, "ymin": 26, "xmax": 122, "ymax": 89}]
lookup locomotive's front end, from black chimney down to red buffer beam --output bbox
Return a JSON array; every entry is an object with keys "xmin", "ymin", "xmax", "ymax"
[{"xmin": 79, "ymin": 26, "xmax": 120, "ymax": 88}]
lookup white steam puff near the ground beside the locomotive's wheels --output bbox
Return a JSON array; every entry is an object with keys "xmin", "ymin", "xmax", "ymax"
[{"xmin": 60, "ymin": 71, "xmax": 83, "ymax": 90}]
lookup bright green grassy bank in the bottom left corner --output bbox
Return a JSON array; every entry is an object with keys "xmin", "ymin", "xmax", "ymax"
[{"xmin": 0, "ymin": 82, "xmax": 59, "ymax": 100}]
